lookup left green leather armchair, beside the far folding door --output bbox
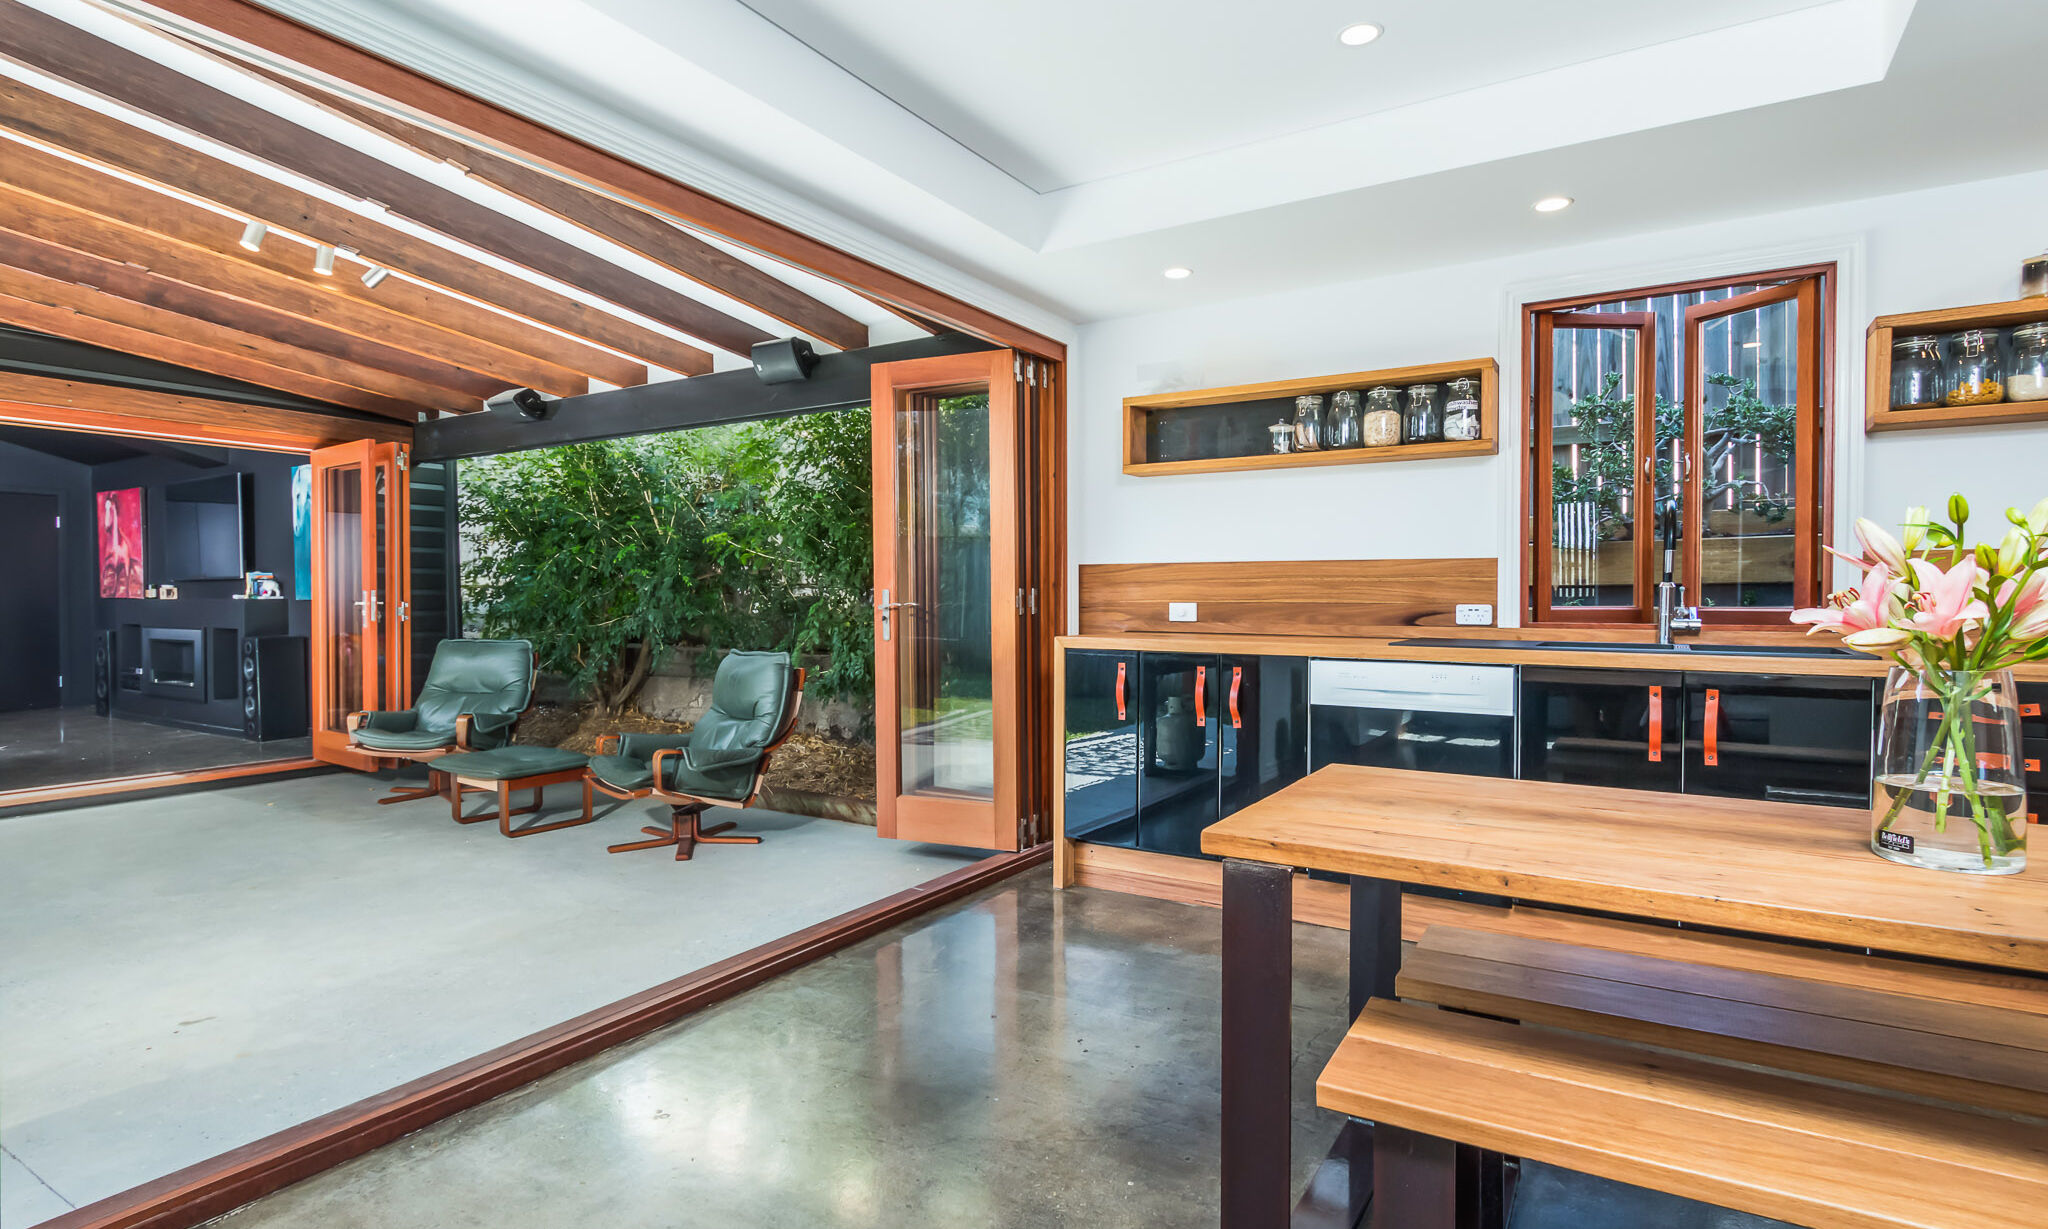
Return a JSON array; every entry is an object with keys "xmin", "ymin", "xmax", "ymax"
[{"xmin": 348, "ymin": 639, "xmax": 535, "ymax": 760}]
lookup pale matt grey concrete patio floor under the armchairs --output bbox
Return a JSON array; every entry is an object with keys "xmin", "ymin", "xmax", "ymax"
[{"xmin": 0, "ymin": 772, "xmax": 979, "ymax": 1229}]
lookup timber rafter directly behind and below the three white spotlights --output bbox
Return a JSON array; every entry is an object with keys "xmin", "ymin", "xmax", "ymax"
[{"xmin": 0, "ymin": 177, "xmax": 590, "ymax": 395}]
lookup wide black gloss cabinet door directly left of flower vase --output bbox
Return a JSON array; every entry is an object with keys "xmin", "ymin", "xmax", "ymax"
[{"xmin": 1686, "ymin": 674, "xmax": 1878, "ymax": 807}]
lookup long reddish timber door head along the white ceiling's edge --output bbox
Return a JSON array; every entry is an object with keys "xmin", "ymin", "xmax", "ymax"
[{"xmin": 150, "ymin": 0, "xmax": 1067, "ymax": 361}]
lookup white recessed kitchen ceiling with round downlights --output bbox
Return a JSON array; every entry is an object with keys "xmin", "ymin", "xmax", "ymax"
[{"xmin": 103, "ymin": 0, "xmax": 2048, "ymax": 334}]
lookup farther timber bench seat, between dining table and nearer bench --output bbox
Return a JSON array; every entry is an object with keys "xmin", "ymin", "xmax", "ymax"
[{"xmin": 1395, "ymin": 926, "xmax": 2048, "ymax": 1120}]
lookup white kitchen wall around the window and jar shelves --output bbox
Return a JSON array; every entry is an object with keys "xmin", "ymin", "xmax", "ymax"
[{"xmin": 1069, "ymin": 172, "xmax": 2048, "ymax": 623}]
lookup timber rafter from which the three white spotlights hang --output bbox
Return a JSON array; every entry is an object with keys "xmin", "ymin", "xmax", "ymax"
[{"xmin": 0, "ymin": 78, "xmax": 711, "ymax": 383}]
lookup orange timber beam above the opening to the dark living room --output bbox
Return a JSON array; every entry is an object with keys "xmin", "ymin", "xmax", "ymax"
[{"xmin": 0, "ymin": 371, "xmax": 412, "ymax": 453}]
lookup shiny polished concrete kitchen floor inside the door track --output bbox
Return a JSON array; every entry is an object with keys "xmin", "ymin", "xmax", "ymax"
[{"xmin": 203, "ymin": 873, "xmax": 1769, "ymax": 1229}]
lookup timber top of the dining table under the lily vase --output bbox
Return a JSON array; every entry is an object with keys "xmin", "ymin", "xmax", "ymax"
[{"xmin": 1202, "ymin": 764, "xmax": 2048, "ymax": 979}]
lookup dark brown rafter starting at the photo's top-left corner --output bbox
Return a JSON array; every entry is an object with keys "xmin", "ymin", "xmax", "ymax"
[{"xmin": 0, "ymin": 0, "xmax": 729, "ymax": 369}]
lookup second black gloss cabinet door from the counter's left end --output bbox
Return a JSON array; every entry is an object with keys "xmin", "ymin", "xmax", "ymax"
[{"xmin": 1139, "ymin": 653, "xmax": 1223, "ymax": 854}]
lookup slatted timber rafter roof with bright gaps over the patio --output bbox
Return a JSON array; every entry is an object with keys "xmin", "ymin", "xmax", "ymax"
[{"xmin": 0, "ymin": 0, "xmax": 909, "ymax": 432}]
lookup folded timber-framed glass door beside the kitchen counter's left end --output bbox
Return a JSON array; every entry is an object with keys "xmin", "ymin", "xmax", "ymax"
[{"xmin": 872, "ymin": 350, "xmax": 1038, "ymax": 850}]
